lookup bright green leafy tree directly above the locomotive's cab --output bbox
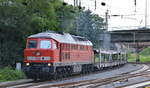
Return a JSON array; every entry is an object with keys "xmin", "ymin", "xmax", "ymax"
[{"xmin": 24, "ymin": 0, "xmax": 61, "ymax": 33}]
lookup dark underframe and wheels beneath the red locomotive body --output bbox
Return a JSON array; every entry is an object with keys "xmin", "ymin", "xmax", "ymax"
[{"xmin": 24, "ymin": 63, "xmax": 94, "ymax": 79}]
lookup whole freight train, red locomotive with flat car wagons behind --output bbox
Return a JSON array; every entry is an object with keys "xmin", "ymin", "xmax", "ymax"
[{"xmin": 24, "ymin": 32, "xmax": 127, "ymax": 79}]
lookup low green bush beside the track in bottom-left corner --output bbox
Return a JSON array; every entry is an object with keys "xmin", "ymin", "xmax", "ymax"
[{"xmin": 0, "ymin": 67, "xmax": 25, "ymax": 81}]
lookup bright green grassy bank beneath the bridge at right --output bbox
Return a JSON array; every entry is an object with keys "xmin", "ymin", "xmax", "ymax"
[{"xmin": 128, "ymin": 48, "xmax": 150, "ymax": 62}]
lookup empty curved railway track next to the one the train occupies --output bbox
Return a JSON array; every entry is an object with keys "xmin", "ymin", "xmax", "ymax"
[{"xmin": 47, "ymin": 65, "xmax": 150, "ymax": 88}]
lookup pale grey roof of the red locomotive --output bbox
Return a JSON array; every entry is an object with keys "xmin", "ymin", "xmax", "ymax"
[{"xmin": 28, "ymin": 32, "xmax": 92, "ymax": 46}]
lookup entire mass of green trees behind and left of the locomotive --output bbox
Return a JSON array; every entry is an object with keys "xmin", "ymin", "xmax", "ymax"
[{"xmin": 0, "ymin": 0, "xmax": 103, "ymax": 66}]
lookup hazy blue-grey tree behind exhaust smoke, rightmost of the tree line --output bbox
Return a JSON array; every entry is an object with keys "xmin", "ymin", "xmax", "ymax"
[{"xmin": 72, "ymin": 10, "xmax": 104, "ymax": 48}]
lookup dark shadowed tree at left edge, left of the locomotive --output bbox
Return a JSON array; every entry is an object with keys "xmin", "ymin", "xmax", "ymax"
[{"xmin": 0, "ymin": 0, "xmax": 30, "ymax": 65}]
